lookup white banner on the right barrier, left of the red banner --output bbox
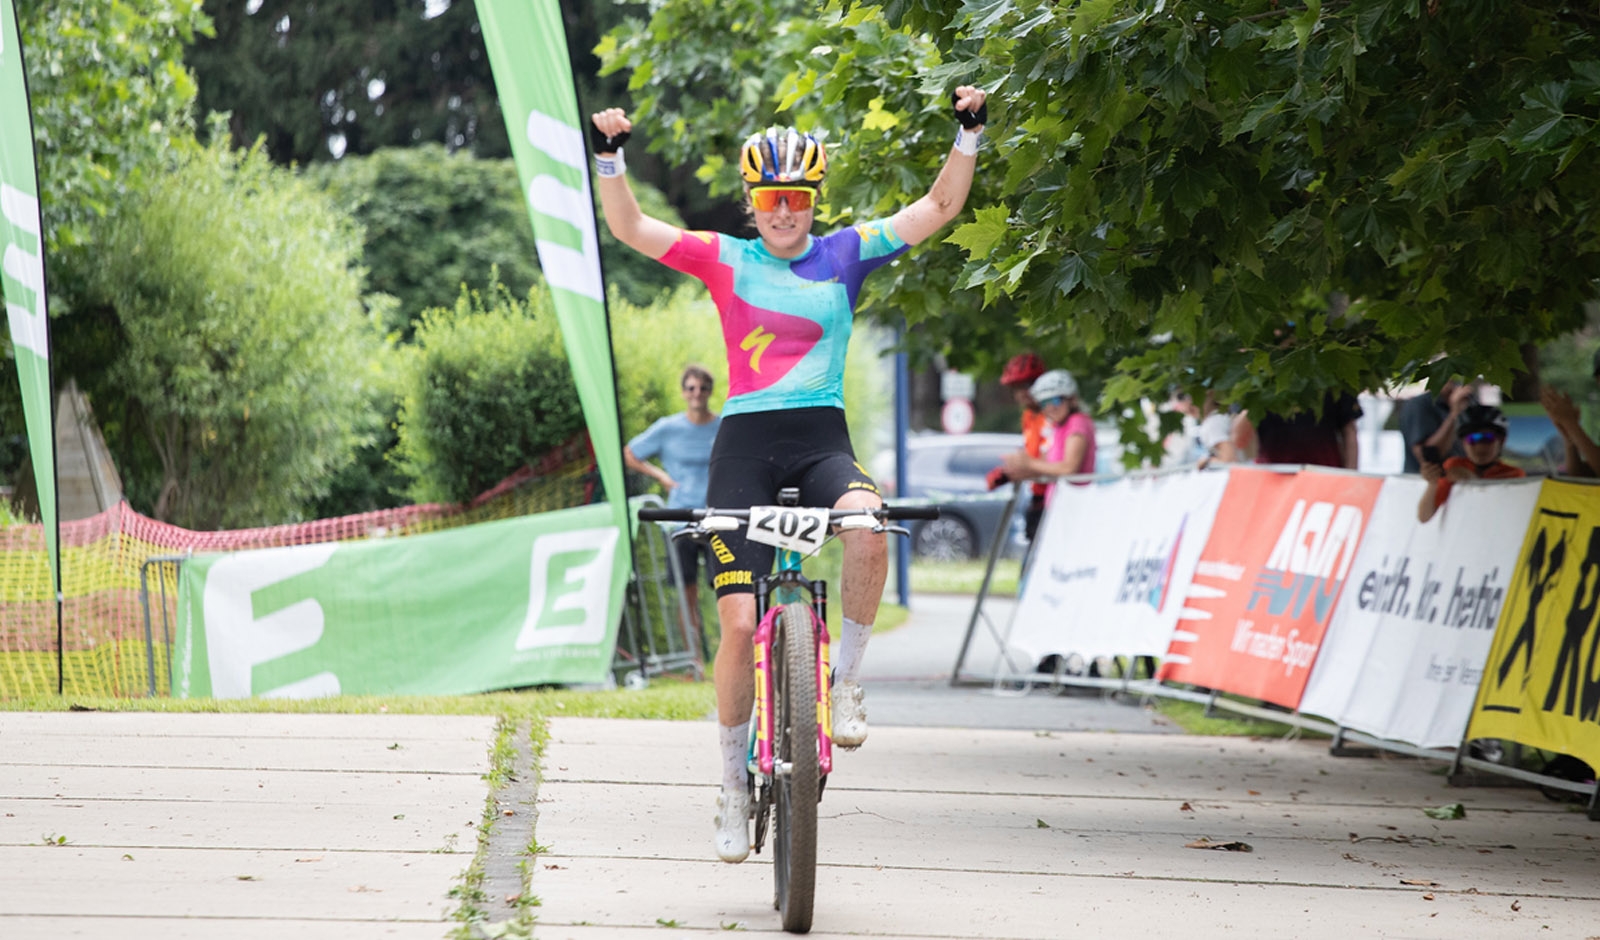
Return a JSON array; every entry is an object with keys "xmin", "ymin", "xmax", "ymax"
[{"xmin": 1008, "ymin": 473, "xmax": 1227, "ymax": 667}]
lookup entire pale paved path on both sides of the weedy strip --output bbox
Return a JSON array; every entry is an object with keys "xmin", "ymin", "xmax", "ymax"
[{"xmin": 0, "ymin": 596, "xmax": 1600, "ymax": 940}]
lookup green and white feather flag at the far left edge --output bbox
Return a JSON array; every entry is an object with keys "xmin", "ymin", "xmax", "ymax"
[{"xmin": 0, "ymin": 0, "xmax": 61, "ymax": 610}]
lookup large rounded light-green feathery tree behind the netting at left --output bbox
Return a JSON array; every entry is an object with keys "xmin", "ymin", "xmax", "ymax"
[{"xmin": 85, "ymin": 144, "xmax": 387, "ymax": 529}]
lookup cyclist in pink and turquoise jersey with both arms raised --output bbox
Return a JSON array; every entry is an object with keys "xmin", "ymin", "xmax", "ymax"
[{"xmin": 590, "ymin": 85, "xmax": 987, "ymax": 862}]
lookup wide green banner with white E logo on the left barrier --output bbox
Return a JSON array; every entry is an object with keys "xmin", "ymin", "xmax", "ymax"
[{"xmin": 171, "ymin": 505, "xmax": 629, "ymax": 699}]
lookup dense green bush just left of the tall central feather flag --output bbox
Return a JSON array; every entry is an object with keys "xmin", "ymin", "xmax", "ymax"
[{"xmin": 390, "ymin": 285, "xmax": 584, "ymax": 502}]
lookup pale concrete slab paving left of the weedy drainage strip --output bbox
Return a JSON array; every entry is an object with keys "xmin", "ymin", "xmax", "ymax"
[{"xmin": 0, "ymin": 713, "xmax": 494, "ymax": 940}]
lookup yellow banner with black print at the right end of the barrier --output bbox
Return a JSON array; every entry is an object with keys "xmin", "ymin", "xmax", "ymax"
[{"xmin": 1465, "ymin": 480, "xmax": 1600, "ymax": 767}]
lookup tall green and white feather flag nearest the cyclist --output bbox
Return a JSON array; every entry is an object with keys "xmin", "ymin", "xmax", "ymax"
[{"xmin": 478, "ymin": 0, "xmax": 627, "ymax": 531}]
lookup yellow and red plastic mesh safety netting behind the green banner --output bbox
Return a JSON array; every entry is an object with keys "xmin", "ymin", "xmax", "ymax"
[{"xmin": 0, "ymin": 436, "xmax": 597, "ymax": 699}]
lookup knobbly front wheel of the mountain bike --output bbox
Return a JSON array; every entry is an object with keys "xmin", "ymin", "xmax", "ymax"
[{"xmin": 773, "ymin": 604, "xmax": 821, "ymax": 934}]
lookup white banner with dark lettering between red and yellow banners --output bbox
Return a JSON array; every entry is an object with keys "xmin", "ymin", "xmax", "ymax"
[{"xmin": 1299, "ymin": 476, "xmax": 1539, "ymax": 748}]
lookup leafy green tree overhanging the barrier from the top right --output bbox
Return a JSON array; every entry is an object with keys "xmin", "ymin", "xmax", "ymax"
[{"xmin": 603, "ymin": 0, "xmax": 1600, "ymax": 409}]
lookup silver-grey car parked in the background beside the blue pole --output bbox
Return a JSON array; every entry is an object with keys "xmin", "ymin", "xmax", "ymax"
[{"xmin": 874, "ymin": 433, "xmax": 1026, "ymax": 560}]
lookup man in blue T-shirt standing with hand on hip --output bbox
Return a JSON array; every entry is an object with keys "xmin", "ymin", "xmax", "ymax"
[{"xmin": 622, "ymin": 366, "xmax": 722, "ymax": 636}]
